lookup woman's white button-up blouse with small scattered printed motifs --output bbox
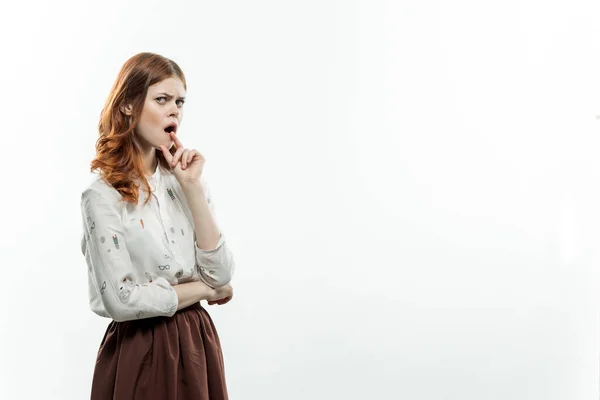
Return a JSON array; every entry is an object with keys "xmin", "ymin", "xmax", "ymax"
[{"xmin": 81, "ymin": 164, "xmax": 235, "ymax": 321}]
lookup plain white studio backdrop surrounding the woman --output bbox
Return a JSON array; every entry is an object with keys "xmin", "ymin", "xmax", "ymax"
[{"xmin": 0, "ymin": 0, "xmax": 600, "ymax": 400}]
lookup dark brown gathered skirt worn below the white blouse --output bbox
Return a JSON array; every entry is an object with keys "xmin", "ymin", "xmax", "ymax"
[{"xmin": 91, "ymin": 303, "xmax": 227, "ymax": 400}]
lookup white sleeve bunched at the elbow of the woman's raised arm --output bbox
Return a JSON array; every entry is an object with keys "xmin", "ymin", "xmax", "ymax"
[{"xmin": 194, "ymin": 178, "xmax": 235, "ymax": 287}]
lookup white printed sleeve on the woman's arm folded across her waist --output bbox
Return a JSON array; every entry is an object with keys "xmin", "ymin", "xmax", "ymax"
[{"xmin": 81, "ymin": 188, "xmax": 178, "ymax": 321}]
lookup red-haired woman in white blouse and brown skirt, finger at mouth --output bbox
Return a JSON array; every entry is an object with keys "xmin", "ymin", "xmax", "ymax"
[{"xmin": 81, "ymin": 53, "xmax": 234, "ymax": 400}]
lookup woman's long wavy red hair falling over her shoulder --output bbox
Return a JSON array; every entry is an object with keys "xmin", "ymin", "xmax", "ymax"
[{"xmin": 91, "ymin": 52, "xmax": 187, "ymax": 205}]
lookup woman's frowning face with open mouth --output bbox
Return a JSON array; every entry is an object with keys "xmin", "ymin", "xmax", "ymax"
[{"xmin": 135, "ymin": 77, "xmax": 186, "ymax": 148}]
